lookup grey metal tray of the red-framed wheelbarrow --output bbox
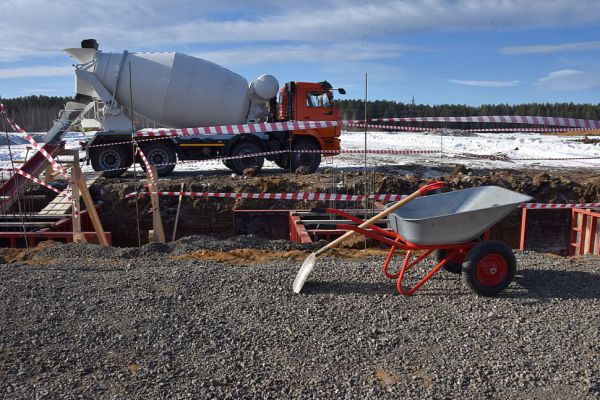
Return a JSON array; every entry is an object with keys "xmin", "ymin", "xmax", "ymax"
[{"xmin": 389, "ymin": 186, "xmax": 531, "ymax": 245}]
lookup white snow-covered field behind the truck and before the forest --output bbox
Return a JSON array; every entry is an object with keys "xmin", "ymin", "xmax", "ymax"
[{"xmin": 0, "ymin": 131, "xmax": 600, "ymax": 171}]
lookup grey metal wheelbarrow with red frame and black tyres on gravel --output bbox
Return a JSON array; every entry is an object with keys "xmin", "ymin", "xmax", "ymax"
[{"xmin": 302, "ymin": 186, "xmax": 531, "ymax": 296}]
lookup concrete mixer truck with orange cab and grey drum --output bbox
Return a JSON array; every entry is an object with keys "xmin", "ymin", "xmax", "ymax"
[{"xmin": 65, "ymin": 39, "xmax": 345, "ymax": 177}]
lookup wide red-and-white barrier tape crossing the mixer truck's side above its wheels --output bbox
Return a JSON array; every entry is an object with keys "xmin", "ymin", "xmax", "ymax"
[{"xmin": 134, "ymin": 121, "xmax": 339, "ymax": 137}]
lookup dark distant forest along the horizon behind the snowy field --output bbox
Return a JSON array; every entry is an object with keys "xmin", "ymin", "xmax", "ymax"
[{"xmin": 0, "ymin": 96, "xmax": 600, "ymax": 132}]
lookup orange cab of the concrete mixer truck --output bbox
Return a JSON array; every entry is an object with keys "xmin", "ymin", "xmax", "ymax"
[{"xmin": 275, "ymin": 81, "xmax": 346, "ymax": 172}]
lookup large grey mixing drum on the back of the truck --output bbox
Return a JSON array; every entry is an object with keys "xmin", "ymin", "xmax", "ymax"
[{"xmin": 65, "ymin": 49, "xmax": 251, "ymax": 128}]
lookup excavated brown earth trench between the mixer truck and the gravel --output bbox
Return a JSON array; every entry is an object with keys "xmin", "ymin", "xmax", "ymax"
[{"xmin": 91, "ymin": 165, "xmax": 600, "ymax": 246}]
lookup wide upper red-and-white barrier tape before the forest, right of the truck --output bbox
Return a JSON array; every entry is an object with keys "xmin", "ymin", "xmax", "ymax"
[{"xmin": 366, "ymin": 115, "xmax": 600, "ymax": 129}]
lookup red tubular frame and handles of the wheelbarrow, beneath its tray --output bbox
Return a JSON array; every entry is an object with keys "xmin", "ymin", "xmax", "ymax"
[{"xmin": 313, "ymin": 208, "xmax": 489, "ymax": 296}]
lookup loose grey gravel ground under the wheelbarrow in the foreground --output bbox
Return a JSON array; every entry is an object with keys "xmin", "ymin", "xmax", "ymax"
[{"xmin": 0, "ymin": 237, "xmax": 600, "ymax": 399}]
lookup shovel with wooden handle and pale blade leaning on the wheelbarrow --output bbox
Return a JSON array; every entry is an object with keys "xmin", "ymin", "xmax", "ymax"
[{"xmin": 292, "ymin": 181, "xmax": 445, "ymax": 293}]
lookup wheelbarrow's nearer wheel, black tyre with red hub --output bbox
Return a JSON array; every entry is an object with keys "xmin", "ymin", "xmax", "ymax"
[{"xmin": 462, "ymin": 240, "xmax": 517, "ymax": 296}]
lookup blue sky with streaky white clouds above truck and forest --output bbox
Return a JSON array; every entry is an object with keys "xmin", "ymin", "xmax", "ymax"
[{"xmin": 0, "ymin": 0, "xmax": 600, "ymax": 105}]
